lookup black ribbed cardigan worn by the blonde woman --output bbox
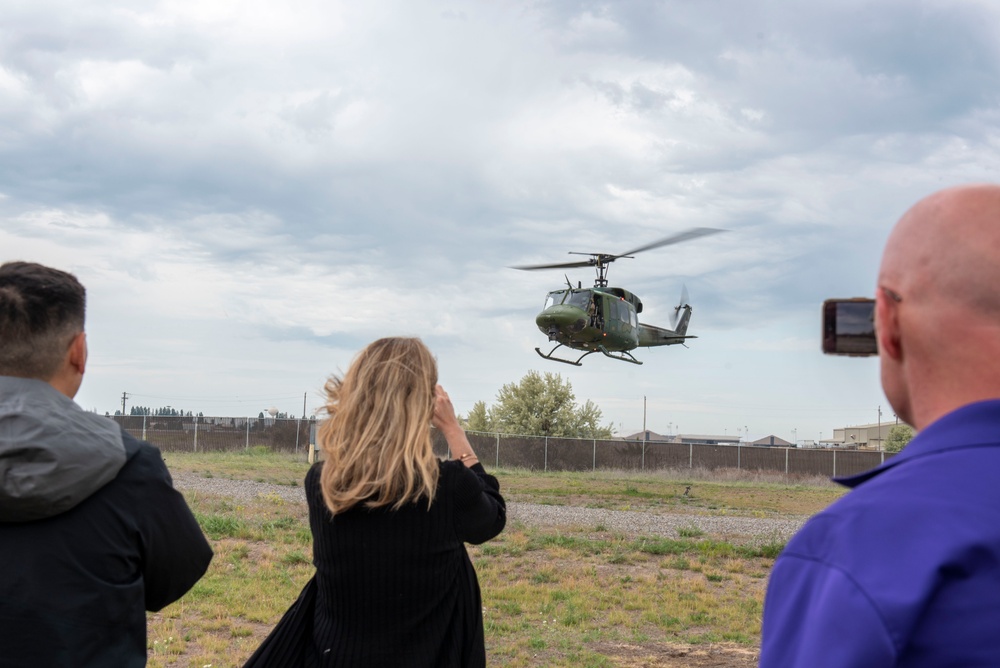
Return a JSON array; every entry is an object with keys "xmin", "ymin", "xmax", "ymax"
[{"xmin": 306, "ymin": 461, "xmax": 506, "ymax": 668}]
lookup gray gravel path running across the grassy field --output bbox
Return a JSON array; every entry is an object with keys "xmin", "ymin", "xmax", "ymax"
[{"xmin": 173, "ymin": 472, "xmax": 806, "ymax": 542}]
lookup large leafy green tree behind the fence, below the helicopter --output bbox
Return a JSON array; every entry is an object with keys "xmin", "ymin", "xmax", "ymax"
[{"xmin": 468, "ymin": 371, "xmax": 613, "ymax": 438}]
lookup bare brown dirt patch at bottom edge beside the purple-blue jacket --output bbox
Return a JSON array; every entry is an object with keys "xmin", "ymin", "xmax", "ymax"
[{"xmin": 590, "ymin": 643, "xmax": 758, "ymax": 668}]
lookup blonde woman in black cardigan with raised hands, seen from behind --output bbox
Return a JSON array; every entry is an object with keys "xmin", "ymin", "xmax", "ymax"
[{"xmin": 248, "ymin": 338, "xmax": 506, "ymax": 668}]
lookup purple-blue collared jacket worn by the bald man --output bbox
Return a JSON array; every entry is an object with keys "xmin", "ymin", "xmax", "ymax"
[{"xmin": 760, "ymin": 400, "xmax": 1000, "ymax": 668}]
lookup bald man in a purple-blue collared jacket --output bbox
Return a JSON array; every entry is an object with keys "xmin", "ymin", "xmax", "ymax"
[{"xmin": 760, "ymin": 185, "xmax": 1000, "ymax": 668}]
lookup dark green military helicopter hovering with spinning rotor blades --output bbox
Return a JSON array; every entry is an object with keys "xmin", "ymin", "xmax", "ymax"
[{"xmin": 512, "ymin": 227, "xmax": 725, "ymax": 366}]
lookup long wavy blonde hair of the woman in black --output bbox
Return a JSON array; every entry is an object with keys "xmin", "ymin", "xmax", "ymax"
[{"xmin": 317, "ymin": 338, "xmax": 439, "ymax": 514}]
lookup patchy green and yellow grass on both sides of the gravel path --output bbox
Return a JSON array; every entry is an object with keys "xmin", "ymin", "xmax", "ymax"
[{"xmin": 149, "ymin": 449, "xmax": 842, "ymax": 668}]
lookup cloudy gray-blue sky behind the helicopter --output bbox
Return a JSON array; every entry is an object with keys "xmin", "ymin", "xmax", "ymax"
[{"xmin": 0, "ymin": 0, "xmax": 1000, "ymax": 440}]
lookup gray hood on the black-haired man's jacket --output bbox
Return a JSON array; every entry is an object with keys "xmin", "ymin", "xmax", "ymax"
[{"xmin": 0, "ymin": 376, "xmax": 125, "ymax": 522}]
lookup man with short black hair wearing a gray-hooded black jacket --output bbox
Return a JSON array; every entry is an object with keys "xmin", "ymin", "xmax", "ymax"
[{"xmin": 0, "ymin": 262, "xmax": 212, "ymax": 668}]
